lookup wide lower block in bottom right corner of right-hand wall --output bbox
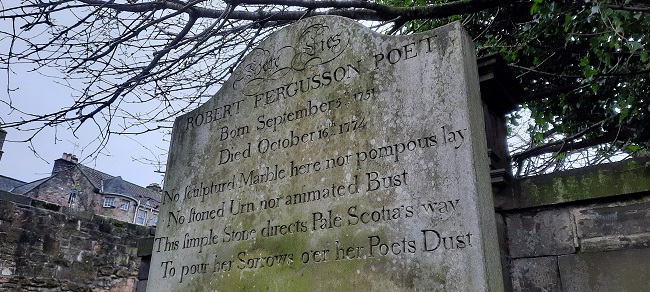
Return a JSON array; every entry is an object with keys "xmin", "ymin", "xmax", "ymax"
[{"xmin": 558, "ymin": 248, "xmax": 650, "ymax": 292}]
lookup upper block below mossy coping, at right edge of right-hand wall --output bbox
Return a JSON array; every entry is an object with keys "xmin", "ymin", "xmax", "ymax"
[{"xmin": 575, "ymin": 198, "xmax": 650, "ymax": 252}]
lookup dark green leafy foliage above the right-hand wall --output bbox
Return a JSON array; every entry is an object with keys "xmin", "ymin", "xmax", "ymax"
[{"xmin": 384, "ymin": 0, "xmax": 650, "ymax": 171}]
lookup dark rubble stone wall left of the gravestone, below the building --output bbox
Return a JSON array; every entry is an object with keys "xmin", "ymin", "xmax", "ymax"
[{"xmin": 0, "ymin": 192, "xmax": 153, "ymax": 291}]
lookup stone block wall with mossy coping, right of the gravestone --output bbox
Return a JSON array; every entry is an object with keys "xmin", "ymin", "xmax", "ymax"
[{"xmin": 495, "ymin": 159, "xmax": 650, "ymax": 291}]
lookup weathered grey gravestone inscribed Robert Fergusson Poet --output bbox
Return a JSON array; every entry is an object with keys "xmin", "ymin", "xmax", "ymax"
[{"xmin": 149, "ymin": 17, "xmax": 503, "ymax": 291}]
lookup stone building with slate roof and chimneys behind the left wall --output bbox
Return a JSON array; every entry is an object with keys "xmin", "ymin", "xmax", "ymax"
[{"xmin": 10, "ymin": 153, "xmax": 161, "ymax": 226}]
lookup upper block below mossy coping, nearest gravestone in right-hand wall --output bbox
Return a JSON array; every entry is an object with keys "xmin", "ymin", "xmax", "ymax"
[{"xmin": 506, "ymin": 209, "xmax": 576, "ymax": 258}]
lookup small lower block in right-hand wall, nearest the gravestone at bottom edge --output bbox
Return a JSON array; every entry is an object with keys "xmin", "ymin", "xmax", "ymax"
[{"xmin": 510, "ymin": 256, "xmax": 562, "ymax": 292}]
